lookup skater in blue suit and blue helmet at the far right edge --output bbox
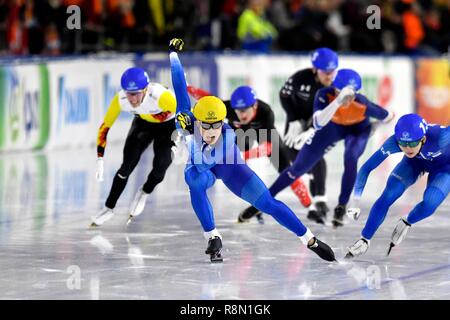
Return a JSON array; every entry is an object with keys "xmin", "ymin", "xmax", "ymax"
[{"xmin": 347, "ymin": 114, "xmax": 450, "ymax": 258}]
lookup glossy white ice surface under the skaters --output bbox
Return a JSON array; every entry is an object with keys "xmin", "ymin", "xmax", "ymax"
[{"xmin": 0, "ymin": 135, "xmax": 450, "ymax": 300}]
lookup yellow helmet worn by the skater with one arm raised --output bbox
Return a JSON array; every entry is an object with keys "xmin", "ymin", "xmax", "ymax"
[{"xmin": 192, "ymin": 96, "xmax": 227, "ymax": 123}]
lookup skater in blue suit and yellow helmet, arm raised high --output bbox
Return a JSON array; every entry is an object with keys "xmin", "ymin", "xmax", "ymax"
[{"xmin": 169, "ymin": 39, "xmax": 335, "ymax": 262}]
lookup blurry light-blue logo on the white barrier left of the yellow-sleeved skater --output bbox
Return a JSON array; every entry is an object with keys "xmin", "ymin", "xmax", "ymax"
[{"xmin": 57, "ymin": 76, "xmax": 89, "ymax": 132}]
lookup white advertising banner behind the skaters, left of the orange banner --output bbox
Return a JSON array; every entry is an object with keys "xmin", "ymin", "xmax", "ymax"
[{"xmin": 217, "ymin": 55, "xmax": 414, "ymax": 131}]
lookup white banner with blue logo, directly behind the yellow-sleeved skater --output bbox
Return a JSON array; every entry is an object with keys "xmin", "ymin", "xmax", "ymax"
[{"xmin": 47, "ymin": 60, "xmax": 133, "ymax": 148}]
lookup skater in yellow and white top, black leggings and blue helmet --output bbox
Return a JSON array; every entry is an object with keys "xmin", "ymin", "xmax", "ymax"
[{"xmin": 92, "ymin": 68, "xmax": 176, "ymax": 226}]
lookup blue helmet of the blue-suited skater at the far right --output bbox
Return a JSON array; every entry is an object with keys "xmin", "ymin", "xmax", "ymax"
[{"xmin": 395, "ymin": 113, "xmax": 428, "ymax": 142}]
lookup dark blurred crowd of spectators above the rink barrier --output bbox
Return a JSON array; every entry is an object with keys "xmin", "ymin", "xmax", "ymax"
[{"xmin": 0, "ymin": 0, "xmax": 450, "ymax": 56}]
